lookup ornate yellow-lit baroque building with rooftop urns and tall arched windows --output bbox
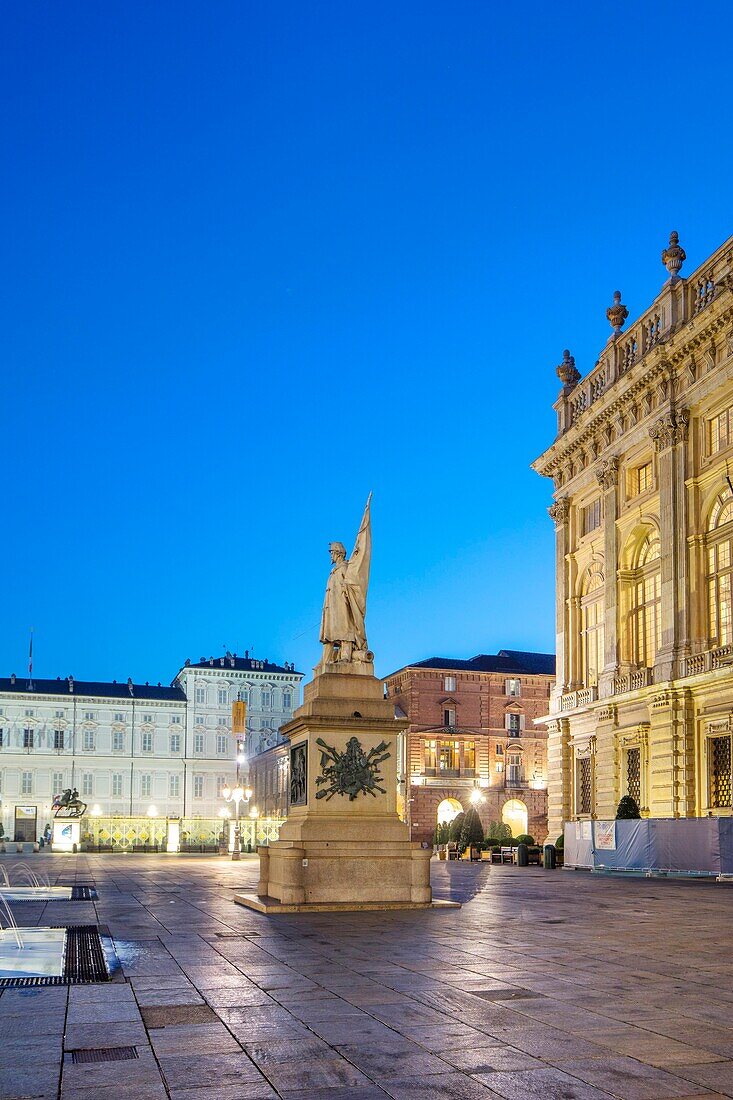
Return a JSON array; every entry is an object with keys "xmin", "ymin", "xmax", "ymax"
[{"xmin": 534, "ymin": 233, "xmax": 733, "ymax": 836}]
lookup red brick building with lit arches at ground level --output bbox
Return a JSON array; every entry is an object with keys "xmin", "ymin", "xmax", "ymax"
[{"xmin": 384, "ymin": 649, "xmax": 555, "ymax": 843}]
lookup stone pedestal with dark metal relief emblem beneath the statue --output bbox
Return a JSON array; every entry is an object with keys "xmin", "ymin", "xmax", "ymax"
[{"xmin": 234, "ymin": 663, "xmax": 453, "ymax": 912}]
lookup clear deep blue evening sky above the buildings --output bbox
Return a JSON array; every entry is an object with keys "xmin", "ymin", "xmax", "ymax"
[{"xmin": 0, "ymin": 0, "xmax": 733, "ymax": 682}]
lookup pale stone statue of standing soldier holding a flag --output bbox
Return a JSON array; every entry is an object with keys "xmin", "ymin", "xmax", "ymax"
[{"xmin": 320, "ymin": 493, "xmax": 374, "ymax": 671}]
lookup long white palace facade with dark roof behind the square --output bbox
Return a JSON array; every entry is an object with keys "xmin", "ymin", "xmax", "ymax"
[{"xmin": 0, "ymin": 653, "xmax": 303, "ymax": 840}]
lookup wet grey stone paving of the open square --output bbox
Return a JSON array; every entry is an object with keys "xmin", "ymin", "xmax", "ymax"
[{"xmin": 0, "ymin": 855, "xmax": 733, "ymax": 1100}]
